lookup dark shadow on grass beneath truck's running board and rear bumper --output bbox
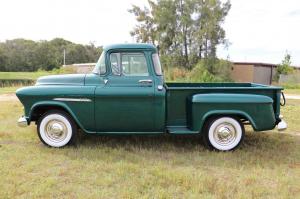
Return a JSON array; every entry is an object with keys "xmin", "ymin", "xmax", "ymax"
[{"xmin": 77, "ymin": 131, "xmax": 293, "ymax": 151}]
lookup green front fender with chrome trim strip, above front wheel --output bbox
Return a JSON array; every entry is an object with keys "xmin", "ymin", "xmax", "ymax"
[{"xmin": 16, "ymin": 85, "xmax": 95, "ymax": 132}]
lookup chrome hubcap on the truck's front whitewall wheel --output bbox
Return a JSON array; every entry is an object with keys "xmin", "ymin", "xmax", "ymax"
[{"xmin": 45, "ymin": 120, "xmax": 67, "ymax": 142}]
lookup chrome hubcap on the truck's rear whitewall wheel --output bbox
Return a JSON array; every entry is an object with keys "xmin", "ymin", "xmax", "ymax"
[{"xmin": 214, "ymin": 123, "xmax": 237, "ymax": 146}]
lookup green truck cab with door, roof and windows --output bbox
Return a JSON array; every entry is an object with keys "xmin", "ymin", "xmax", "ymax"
[{"xmin": 86, "ymin": 44, "xmax": 166, "ymax": 133}]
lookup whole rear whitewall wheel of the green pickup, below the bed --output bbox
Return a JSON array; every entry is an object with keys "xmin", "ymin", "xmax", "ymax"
[{"xmin": 203, "ymin": 117, "xmax": 245, "ymax": 151}]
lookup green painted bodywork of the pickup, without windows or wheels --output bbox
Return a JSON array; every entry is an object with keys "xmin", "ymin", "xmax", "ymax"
[{"xmin": 16, "ymin": 44, "xmax": 282, "ymax": 134}]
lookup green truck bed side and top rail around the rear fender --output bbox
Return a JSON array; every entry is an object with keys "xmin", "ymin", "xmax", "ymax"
[{"xmin": 165, "ymin": 83, "xmax": 282, "ymax": 129}]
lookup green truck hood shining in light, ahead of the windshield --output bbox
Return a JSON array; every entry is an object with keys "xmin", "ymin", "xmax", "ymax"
[{"xmin": 36, "ymin": 74, "xmax": 86, "ymax": 85}]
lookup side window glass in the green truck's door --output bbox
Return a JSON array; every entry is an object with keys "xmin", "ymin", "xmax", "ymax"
[{"xmin": 110, "ymin": 53, "xmax": 149, "ymax": 76}]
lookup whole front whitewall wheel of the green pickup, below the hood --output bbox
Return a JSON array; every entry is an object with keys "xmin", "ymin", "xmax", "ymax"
[{"xmin": 37, "ymin": 110, "xmax": 77, "ymax": 148}]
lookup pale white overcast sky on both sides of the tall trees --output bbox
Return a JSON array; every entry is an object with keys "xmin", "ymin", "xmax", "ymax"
[{"xmin": 0, "ymin": 0, "xmax": 300, "ymax": 66}]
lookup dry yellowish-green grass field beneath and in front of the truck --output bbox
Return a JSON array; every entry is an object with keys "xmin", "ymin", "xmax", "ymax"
[{"xmin": 0, "ymin": 100, "xmax": 300, "ymax": 198}]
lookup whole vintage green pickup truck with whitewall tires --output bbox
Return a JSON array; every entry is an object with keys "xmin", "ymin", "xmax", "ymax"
[{"xmin": 16, "ymin": 44, "xmax": 287, "ymax": 151}]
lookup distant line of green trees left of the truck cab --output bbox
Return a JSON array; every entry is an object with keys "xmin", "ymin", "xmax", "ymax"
[{"xmin": 0, "ymin": 38, "xmax": 102, "ymax": 71}]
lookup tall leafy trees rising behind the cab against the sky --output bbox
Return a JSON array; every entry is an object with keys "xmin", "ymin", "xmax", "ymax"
[{"xmin": 129, "ymin": 0, "xmax": 231, "ymax": 70}]
